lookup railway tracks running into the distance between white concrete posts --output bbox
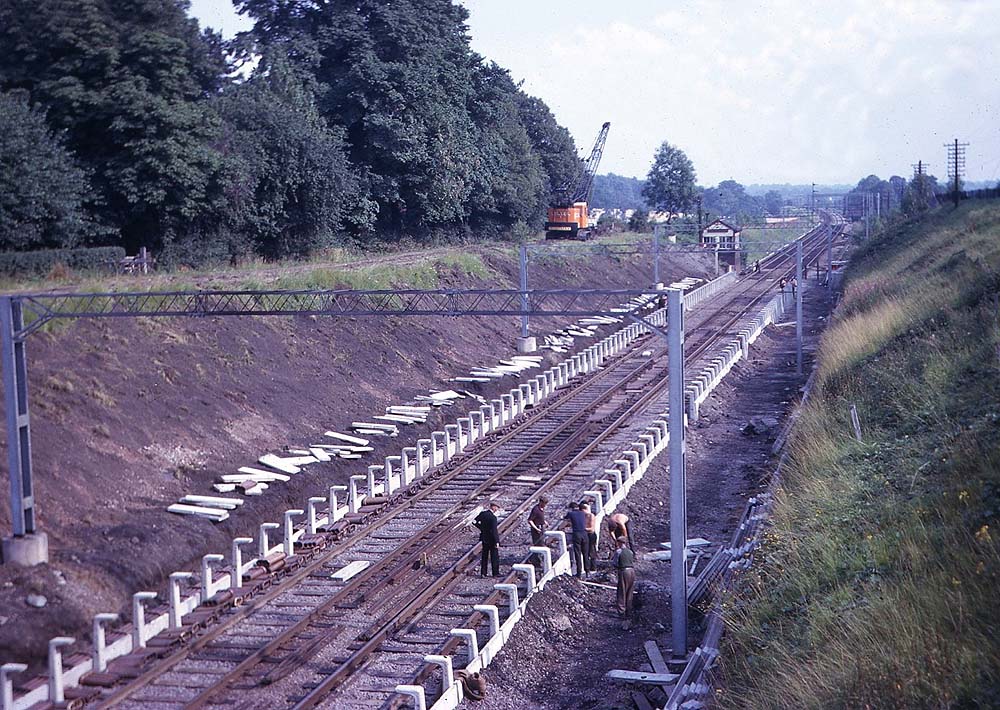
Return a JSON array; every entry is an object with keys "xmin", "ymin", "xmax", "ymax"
[{"xmin": 70, "ymin": 224, "xmax": 825, "ymax": 709}]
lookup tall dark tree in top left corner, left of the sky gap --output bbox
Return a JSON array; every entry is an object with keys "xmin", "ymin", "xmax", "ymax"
[{"xmin": 0, "ymin": 0, "xmax": 225, "ymax": 253}]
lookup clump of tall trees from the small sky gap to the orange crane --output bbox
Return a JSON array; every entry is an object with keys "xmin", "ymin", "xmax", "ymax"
[{"xmin": 239, "ymin": 0, "xmax": 579, "ymax": 239}]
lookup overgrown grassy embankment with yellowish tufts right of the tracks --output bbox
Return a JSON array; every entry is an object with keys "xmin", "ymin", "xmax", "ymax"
[{"xmin": 719, "ymin": 202, "xmax": 1000, "ymax": 708}]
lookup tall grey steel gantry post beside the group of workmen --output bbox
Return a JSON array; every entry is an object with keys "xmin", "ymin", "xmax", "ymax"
[{"xmin": 667, "ymin": 289, "xmax": 688, "ymax": 659}]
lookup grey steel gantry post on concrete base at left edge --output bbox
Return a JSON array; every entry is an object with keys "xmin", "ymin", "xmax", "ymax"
[{"xmin": 0, "ymin": 296, "xmax": 35, "ymax": 537}]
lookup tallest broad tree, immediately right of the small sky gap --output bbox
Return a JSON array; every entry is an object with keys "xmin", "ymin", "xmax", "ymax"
[{"xmin": 240, "ymin": 0, "xmax": 477, "ymax": 235}]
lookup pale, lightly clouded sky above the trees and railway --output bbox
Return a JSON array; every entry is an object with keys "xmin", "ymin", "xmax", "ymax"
[{"xmin": 191, "ymin": 0, "xmax": 1000, "ymax": 185}]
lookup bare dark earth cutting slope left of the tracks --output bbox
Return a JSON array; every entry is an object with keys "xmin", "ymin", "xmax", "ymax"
[{"xmin": 0, "ymin": 247, "xmax": 708, "ymax": 668}]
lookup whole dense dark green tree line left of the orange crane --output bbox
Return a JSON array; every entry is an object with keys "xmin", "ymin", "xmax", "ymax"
[{"xmin": 0, "ymin": 0, "xmax": 581, "ymax": 261}]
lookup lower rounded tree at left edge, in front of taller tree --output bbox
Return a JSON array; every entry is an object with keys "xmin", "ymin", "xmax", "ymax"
[{"xmin": 0, "ymin": 93, "xmax": 104, "ymax": 250}]
